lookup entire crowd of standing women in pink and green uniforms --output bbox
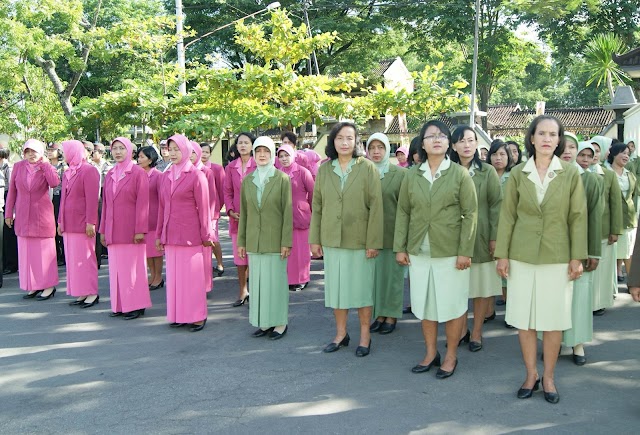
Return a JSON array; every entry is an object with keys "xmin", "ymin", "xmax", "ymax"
[{"xmin": 0, "ymin": 115, "xmax": 640, "ymax": 403}]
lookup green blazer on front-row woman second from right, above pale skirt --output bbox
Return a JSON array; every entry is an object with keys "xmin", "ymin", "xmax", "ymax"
[{"xmin": 393, "ymin": 162, "xmax": 478, "ymax": 258}]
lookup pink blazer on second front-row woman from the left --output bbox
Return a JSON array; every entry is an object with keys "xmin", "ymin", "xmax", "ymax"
[{"xmin": 58, "ymin": 162, "xmax": 100, "ymax": 233}]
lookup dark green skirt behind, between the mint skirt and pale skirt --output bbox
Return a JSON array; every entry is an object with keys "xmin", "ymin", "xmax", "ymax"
[{"xmin": 373, "ymin": 249, "xmax": 405, "ymax": 319}]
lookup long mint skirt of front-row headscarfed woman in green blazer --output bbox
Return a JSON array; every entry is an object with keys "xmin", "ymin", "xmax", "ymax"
[{"xmin": 249, "ymin": 252, "xmax": 289, "ymax": 329}]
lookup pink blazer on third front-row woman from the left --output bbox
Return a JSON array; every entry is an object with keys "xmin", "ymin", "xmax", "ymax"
[{"xmin": 100, "ymin": 165, "xmax": 149, "ymax": 245}]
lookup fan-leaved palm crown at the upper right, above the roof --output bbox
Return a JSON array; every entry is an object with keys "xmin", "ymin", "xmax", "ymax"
[{"xmin": 584, "ymin": 33, "xmax": 629, "ymax": 101}]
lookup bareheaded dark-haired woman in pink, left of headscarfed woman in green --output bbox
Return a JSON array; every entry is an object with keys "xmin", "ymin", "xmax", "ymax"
[{"xmin": 224, "ymin": 133, "xmax": 256, "ymax": 307}]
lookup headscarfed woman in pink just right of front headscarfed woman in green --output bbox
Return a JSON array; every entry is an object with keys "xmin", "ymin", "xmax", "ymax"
[{"xmin": 278, "ymin": 145, "xmax": 313, "ymax": 291}]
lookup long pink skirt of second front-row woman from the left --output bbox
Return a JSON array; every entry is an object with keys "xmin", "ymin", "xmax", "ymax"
[{"xmin": 63, "ymin": 233, "xmax": 98, "ymax": 297}]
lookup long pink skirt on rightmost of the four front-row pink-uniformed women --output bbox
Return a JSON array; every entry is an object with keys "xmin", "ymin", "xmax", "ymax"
[{"xmin": 165, "ymin": 245, "xmax": 211, "ymax": 323}]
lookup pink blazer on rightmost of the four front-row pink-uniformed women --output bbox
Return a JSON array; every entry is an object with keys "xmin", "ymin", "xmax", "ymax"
[{"xmin": 156, "ymin": 167, "xmax": 213, "ymax": 246}]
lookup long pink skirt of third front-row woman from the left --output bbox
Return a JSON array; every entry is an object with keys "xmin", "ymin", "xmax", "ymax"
[{"xmin": 108, "ymin": 243, "xmax": 151, "ymax": 313}]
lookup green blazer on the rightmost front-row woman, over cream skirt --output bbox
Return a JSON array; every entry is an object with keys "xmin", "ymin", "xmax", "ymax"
[{"xmin": 495, "ymin": 161, "xmax": 587, "ymax": 264}]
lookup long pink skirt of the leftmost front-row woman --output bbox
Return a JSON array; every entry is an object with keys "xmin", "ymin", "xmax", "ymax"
[{"xmin": 18, "ymin": 236, "xmax": 60, "ymax": 292}]
